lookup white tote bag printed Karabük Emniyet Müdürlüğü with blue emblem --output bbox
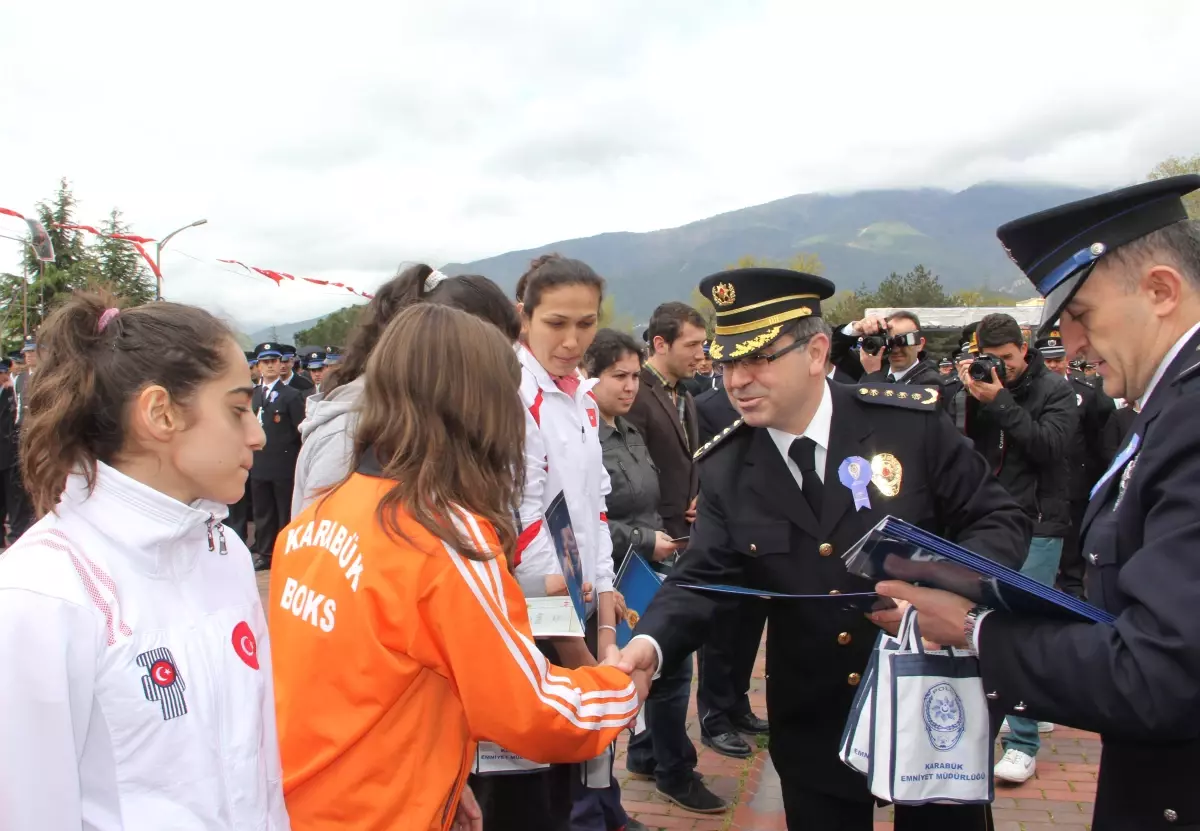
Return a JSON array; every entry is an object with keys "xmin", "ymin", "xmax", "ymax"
[{"xmin": 868, "ymin": 610, "xmax": 995, "ymax": 805}]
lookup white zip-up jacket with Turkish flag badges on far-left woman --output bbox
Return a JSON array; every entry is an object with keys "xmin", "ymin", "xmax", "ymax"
[{"xmin": 0, "ymin": 464, "xmax": 289, "ymax": 831}]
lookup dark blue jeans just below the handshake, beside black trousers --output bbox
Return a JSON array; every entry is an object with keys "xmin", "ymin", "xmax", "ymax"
[{"xmin": 625, "ymin": 654, "xmax": 696, "ymax": 791}]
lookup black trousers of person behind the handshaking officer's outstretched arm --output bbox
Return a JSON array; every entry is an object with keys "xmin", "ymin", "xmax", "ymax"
[{"xmin": 696, "ymin": 596, "xmax": 767, "ymax": 737}]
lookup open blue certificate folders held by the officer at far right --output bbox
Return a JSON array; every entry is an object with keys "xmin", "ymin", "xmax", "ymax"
[{"xmin": 842, "ymin": 516, "xmax": 1116, "ymax": 623}]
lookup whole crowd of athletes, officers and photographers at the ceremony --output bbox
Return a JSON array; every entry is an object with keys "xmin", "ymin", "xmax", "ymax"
[{"xmin": 0, "ymin": 170, "xmax": 1200, "ymax": 831}]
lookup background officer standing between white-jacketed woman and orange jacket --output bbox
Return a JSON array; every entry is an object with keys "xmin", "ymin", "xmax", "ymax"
[{"xmin": 250, "ymin": 343, "xmax": 305, "ymax": 570}]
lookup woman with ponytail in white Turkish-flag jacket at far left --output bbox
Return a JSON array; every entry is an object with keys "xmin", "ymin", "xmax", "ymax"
[{"xmin": 0, "ymin": 295, "xmax": 288, "ymax": 831}]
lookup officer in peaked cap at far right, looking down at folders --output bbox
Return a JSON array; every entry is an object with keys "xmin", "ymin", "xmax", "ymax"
[{"xmin": 880, "ymin": 175, "xmax": 1200, "ymax": 831}]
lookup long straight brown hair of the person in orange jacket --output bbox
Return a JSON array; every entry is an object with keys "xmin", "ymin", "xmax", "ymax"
[{"xmin": 354, "ymin": 303, "xmax": 524, "ymax": 560}]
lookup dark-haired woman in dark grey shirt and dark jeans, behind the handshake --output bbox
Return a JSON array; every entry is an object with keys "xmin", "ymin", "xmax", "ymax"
[{"xmin": 583, "ymin": 329, "xmax": 725, "ymax": 827}]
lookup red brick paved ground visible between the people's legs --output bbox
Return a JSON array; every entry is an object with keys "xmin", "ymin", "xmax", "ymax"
[{"xmin": 258, "ymin": 572, "xmax": 1100, "ymax": 831}]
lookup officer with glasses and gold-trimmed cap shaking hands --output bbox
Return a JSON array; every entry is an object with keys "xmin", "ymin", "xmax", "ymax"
[{"xmin": 620, "ymin": 268, "xmax": 1031, "ymax": 831}]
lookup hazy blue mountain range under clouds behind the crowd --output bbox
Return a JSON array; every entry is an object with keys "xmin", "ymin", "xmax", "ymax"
[{"xmin": 442, "ymin": 184, "xmax": 1094, "ymax": 319}]
